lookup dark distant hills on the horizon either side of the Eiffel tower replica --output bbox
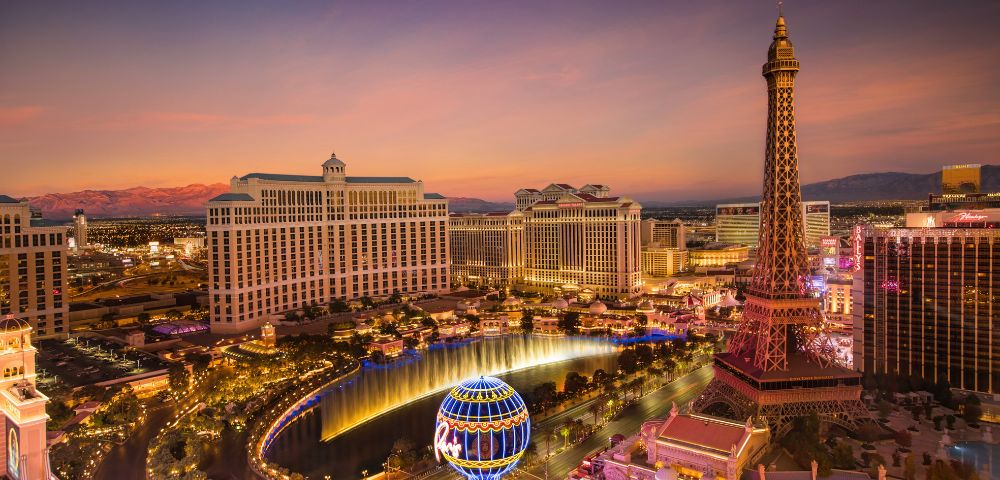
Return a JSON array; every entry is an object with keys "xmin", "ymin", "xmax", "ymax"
[{"xmin": 672, "ymin": 165, "xmax": 1000, "ymax": 205}]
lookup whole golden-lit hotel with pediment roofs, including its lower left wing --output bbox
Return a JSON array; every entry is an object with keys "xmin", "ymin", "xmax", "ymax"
[{"xmin": 449, "ymin": 183, "xmax": 642, "ymax": 298}]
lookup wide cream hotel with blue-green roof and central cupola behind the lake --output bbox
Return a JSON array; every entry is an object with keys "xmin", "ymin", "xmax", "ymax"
[{"xmin": 207, "ymin": 155, "xmax": 450, "ymax": 333}]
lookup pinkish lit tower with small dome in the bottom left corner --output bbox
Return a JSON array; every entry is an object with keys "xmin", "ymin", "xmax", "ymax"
[{"xmin": 0, "ymin": 316, "xmax": 55, "ymax": 480}]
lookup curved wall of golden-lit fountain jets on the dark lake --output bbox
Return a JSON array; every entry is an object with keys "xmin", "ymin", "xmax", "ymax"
[{"xmin": 320, "ymin": 337, "xmax": 616, "ymax": 440}]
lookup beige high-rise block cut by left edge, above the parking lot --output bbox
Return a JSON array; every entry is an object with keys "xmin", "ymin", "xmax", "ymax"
[{"xmin": 0, "ymin": 195, "xmax": 69, "ymax": 338}]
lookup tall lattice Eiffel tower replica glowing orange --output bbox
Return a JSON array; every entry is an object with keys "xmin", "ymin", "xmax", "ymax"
[{"xmin": 693, "ymin": 13, "xmax": 870, "ymax": 437}]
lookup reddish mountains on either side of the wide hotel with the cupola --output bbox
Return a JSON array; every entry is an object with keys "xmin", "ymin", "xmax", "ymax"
[{"xmin": 17, "ymin": 183, "xmax": 514, "ymax": 220}]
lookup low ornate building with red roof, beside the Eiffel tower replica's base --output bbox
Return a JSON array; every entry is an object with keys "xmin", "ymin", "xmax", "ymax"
[{"xmin": 591, "ymin": 405, "xmax": 770, "ymax": 480}]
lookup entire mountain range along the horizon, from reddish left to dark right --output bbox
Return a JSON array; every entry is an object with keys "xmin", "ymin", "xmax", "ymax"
[{"xmin": 9, "ymin": 165, "xmax": 1000, "ymax": 220}]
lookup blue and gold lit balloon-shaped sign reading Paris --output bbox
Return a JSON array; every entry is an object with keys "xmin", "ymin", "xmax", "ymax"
[{"xmin": 434, "ymin": 377, "xmax": 531, "ymax": 480}]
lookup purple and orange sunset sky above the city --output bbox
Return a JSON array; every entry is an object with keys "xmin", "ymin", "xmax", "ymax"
[{"xmin": 0, "ymin": 0, "xmax": 1000, "ymax": 200}]
